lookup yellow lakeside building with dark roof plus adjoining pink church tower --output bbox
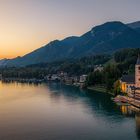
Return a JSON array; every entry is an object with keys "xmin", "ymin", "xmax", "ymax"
[{"xmin": 120, "ymin": 56, "xmax": 140, "ymax": 95}]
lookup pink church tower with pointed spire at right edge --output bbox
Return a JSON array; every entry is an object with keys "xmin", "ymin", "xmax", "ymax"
[{"xmin": 135, "ymin": 55, "xmax": 140, "ymax": 87}]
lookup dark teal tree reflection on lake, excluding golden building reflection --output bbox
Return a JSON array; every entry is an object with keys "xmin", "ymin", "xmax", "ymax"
[{"xmin": 48, "ymin": 83, "xmax": 124, "ymax": 121}]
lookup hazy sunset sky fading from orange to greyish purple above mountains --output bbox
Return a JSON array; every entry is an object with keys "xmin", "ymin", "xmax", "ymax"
[{"xmin": 0, "ymin": 0, "xmax": 140, "ymax": 58}]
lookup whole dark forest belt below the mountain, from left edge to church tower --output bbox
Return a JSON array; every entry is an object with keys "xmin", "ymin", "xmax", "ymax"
[{"xmin": 0, "ymin": 48, "xmax": 140, "ymax": 94}]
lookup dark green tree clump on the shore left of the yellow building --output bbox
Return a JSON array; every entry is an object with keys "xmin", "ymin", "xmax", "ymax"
[{"xmin": 86, "ymin": 64, "xmax": 121, "ymax": 92}]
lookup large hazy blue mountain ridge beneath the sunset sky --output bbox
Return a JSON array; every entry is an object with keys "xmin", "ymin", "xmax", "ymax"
[{"xmin": 0, "ymin": 21, "xmax": 140, "ymax": 66}]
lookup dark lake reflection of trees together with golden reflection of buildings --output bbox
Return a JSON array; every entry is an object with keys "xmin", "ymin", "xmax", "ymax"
[{"xmin": 49, "ymin": 84, "xmax": 140, "ymax": 139}]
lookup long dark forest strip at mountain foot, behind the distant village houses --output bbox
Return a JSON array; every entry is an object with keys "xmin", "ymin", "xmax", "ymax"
[{"xmin": 0, "ymin": 55, "xmax": 111, "ymax": 78}]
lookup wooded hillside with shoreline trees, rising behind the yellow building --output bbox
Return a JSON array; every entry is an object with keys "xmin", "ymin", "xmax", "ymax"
[{"xmin": 86, "ymin": 48, "xmax": 140, "ymax": 94}]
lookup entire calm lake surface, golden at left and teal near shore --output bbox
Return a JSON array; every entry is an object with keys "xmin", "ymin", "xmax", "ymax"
[{"xmin": 0, "ymin": 83, "xmax": 140, "ymax": 140}]
